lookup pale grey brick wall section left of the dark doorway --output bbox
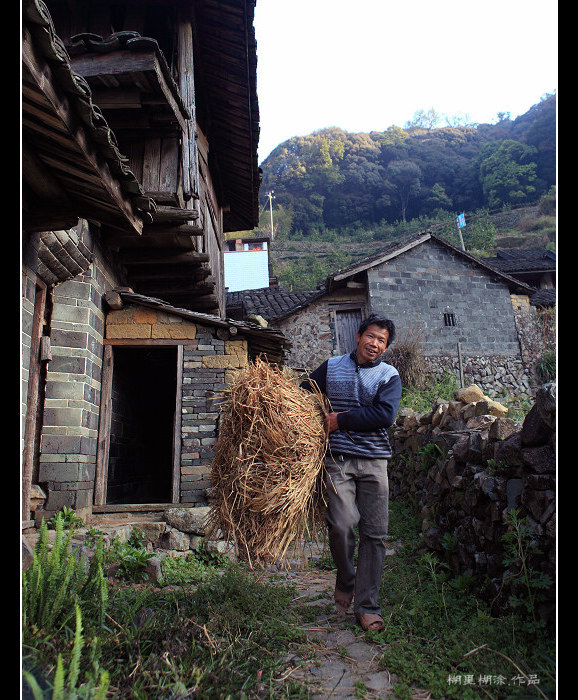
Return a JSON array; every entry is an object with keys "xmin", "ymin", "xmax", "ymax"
[{"xmin": 37, "ymin": 243, "xmax": 117, "ymax": 517}]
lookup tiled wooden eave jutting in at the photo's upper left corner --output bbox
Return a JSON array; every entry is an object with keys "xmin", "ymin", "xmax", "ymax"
[{"xmin": 22, "ymin": 0, "xmax": 155, "ymax": 233}]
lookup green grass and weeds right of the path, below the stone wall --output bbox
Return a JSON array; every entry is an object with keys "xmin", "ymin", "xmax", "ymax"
[{"xmin": 371, "ymin": 501, "xmax": 555, "ymax": 700}]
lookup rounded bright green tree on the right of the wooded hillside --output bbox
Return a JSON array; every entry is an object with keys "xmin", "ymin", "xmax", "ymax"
[{"xmin": 480, "ymin": 140, "xmax": 537, "ymax": 209}]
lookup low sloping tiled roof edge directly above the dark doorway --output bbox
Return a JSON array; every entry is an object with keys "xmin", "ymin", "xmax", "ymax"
[{"xmin": 113, "ymin": 288, "xmax": 291, "ymax": 362}]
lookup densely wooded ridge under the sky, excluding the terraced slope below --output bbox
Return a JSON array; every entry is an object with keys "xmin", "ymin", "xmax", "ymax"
[{"xmin": 254, "ymin": 94, "xmax": 556, "ymax": 237}]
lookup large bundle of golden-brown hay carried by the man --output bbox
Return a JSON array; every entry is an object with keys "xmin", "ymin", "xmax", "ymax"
[{"xmin": 210, "ymin": 360, "xmax": 327, "ymax": 565}]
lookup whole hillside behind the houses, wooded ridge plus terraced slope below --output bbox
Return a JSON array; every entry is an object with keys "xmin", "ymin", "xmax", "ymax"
[{"xmin": 234, "ymin": 94, "xmax": 556, "ymax": 289}]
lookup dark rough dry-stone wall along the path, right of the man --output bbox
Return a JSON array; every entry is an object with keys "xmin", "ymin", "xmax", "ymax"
[{"xmin": 389, "ymin": 384, "xmax": 556, "ymax": 622}]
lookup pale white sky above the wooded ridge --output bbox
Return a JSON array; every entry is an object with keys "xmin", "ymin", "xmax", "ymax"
[{"xmin": 254, "ymin": 0, "xmax": 558, "ymax": 163}]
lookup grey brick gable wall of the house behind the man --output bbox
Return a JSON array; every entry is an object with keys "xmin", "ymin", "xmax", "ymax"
[{"xmin": 368, "ymin": 241, "xmax": 520, "ymax": 357}]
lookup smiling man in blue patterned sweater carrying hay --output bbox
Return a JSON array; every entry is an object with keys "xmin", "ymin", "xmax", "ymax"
[{"xmin": 301, "ymin": 315, "xmax": 401, "ymax": 630}]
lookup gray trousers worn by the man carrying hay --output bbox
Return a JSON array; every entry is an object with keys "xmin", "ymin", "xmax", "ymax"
[{"xmin": 325, "ymin": 454, "xmax": 389, "ymax": 618}]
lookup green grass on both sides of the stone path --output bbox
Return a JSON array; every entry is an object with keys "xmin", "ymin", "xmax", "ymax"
[{"xmin": 23, "ymin": 500, "xmax": 555, "ymax": 700}]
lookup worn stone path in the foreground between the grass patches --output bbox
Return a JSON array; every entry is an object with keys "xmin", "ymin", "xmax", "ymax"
[{"xmin": 268, "ymin": 570, "xmax": 430, "ymax": 700}]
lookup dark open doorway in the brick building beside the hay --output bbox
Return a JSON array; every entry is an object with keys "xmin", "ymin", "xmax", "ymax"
[{"xmin": 106, "ymin": 347, "xmax": 177, "ymax": 504}]
